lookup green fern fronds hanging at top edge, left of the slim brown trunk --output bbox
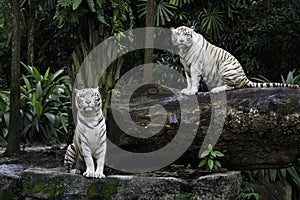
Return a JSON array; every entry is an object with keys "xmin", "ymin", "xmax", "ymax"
[{"xmin": 54, "ymin": 0, "xmax": 134, "ymax": 33}]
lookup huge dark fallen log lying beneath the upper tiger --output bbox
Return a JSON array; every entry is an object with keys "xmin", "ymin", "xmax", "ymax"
[{"xmin": 107, "ymin": 85, "xmax": 300, "ymax": 170}]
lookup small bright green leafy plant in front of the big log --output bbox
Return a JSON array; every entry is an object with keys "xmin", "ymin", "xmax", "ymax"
[{"xmin": 198, "ymin": 144, "xmax": 224, "ymax": 171}]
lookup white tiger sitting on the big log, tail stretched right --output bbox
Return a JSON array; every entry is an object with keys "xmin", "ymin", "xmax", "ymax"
[{"xmin": 171, "ymin": 26, "xmax": 299, "ymax": 95}]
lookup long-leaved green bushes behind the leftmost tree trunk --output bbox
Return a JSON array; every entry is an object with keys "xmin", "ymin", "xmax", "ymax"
[{"xmin": 0, "ymin": 64, "xmax": 70, "ymax": 145}]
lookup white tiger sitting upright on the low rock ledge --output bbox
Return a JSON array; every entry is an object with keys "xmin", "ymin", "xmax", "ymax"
[{"xmin": 64, "ymin": 88, "xmax": 106, "ymax": 178}]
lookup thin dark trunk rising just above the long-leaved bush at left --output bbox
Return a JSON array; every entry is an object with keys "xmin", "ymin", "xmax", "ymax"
[{"xmin": 27, "ymin": 0, "xmax": 36, "ymax": 66}]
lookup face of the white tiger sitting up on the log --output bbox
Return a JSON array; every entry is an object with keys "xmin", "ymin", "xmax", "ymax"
[{"xmin": 171, "ymin": 26, "xmax": 194, "ymax": 49}]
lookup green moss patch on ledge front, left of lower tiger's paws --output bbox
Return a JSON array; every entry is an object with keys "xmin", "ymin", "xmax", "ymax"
[{"xmin": 23, "ymin": 179, "xmax": 67, "ymax": 198}]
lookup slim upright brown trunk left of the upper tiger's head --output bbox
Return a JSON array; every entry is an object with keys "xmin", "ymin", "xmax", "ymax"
[{"xmin": 144, "ymin": 0, "xmax": 155, "ymax": 82}]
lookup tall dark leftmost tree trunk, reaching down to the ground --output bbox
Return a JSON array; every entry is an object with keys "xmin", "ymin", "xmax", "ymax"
[{"xmin": 6, "ymin": 0, "xmax": 20, "ymax": 154}]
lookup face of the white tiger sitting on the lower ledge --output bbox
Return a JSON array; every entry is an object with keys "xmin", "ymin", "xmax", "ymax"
[{"xmin": 75, "ymin": 87, "xmax": 102, "ymax": 112}]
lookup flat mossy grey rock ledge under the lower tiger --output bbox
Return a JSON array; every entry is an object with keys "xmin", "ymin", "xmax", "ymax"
[{"xmin": 0, "ymin": 166, "xmax": 242, "ymax": 200}]
